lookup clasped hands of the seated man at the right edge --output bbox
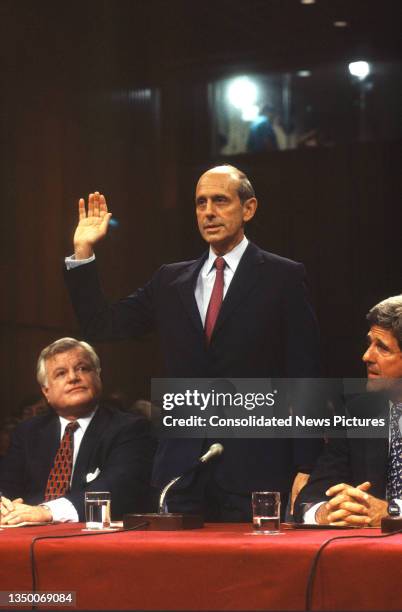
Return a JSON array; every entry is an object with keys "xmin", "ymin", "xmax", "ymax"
[{"xmin": 316, "ymin": 482, "xmax": 388, "ymax": 527}]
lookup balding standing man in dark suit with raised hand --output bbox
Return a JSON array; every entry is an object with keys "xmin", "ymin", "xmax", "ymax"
[{"xmin": 66, "ymin": 166, "xmax": 319, "ymax": 521}]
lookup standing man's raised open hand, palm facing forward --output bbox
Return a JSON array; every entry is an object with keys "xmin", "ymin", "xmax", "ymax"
[{"xmin": 74, "ymin": 191, "xmax": 112, "ymax": 259}]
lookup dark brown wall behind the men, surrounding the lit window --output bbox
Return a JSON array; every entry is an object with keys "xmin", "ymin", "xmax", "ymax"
[{"xmin": 0, "ymin": 0, "xmax": 402, "ymax": 414}]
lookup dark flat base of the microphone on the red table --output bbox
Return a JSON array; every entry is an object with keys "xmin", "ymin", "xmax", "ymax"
[{"xmin": 123, "ymin": 512, "xmax": 204, "ymax": 531}]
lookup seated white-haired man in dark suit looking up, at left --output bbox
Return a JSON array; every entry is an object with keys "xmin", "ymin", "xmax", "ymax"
[{"xmin": 0, "ymin": 338, "xmax": 153, "ymax": 525}]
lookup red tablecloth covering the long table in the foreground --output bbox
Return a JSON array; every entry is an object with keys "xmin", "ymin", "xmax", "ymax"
[{"xmin": 0, "ymin": 524, "xmax": 402, "ymax": 610}]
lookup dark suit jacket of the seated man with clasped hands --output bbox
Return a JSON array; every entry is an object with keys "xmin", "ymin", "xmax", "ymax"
[{"xmin": 295, "ymin": 393, "xmax": 389, "ymax": 522}]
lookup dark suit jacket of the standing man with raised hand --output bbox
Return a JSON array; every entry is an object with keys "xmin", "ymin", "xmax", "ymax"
[{"xmin": 66, "ymin": 243, "xmax": 319, "ymax": 500}]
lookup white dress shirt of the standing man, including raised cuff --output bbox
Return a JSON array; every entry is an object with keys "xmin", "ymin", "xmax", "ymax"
[{"xmin": 65, "ymin": 236, "xmax": 248, "ymax": 326}]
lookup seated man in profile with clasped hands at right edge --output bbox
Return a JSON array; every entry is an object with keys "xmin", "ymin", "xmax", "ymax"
[{"xmin": 295, "ymin": 295, "xmax": 402, "ymax": 526}]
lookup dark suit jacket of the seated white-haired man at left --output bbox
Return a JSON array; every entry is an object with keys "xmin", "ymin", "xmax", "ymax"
[{"xmin": 0, "ymin": 406, "xmax": 154, "ymax": 520}]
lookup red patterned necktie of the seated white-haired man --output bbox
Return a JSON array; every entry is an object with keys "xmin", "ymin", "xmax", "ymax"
[{"xmin": 45, "ymin": 421, "xmax": 79, "ymax": 501}]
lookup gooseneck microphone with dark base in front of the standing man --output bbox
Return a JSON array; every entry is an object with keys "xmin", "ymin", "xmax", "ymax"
[{"xmin": 123, "ymin": 442, "xmax": 223, "ymax": 531}]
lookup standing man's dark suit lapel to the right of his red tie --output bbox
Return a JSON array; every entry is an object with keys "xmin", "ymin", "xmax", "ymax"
[{"xmin": 211, "ymin": 242, "xmax": 264, "ymax": 342}]
